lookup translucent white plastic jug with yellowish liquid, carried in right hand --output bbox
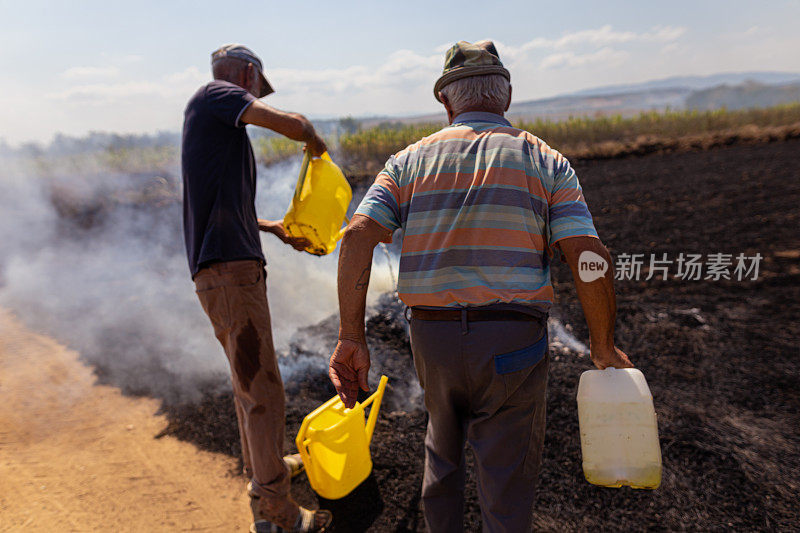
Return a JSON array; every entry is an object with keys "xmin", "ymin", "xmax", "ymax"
[{"xmin": 578, "ymin": 368, "xmax": 661, "ymax": 489}]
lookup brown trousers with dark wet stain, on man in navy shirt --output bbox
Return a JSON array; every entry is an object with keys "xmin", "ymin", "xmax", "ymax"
[{"xmin": 194, "ymin": 260, "xmax": 290, "ymax": 499}]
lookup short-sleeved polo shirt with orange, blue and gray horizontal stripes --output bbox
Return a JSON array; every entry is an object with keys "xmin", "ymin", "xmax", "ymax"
[{"xmin": 356, "ymin": 112, "xmax": 597, "ymax": 312}]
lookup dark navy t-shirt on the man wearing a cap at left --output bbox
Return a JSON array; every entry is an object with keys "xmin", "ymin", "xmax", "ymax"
[{"xmin": 181, "ymin": 80, "xmax": 264, "ymax": 277}]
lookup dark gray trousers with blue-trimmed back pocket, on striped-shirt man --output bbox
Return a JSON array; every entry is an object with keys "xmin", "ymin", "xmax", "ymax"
[{"xmin": 411, "ymin": 312, "xmax": 549, "ymax": 533}]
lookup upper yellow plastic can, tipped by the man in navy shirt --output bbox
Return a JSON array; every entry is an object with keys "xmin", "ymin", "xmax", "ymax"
[{"xmin": 283, "ymin": 150, "xmax": 353, "ymax": 255}]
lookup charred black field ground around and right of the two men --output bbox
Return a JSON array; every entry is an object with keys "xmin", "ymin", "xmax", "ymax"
[{"xmin": 158, "ymin": 140, "xmax": 800, "ymax": 531}]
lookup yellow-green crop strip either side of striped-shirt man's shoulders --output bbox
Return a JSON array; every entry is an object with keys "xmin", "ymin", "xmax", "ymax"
[{"xmin": 332, "ymin": 103, "xmax": 800, "ymax": 174}]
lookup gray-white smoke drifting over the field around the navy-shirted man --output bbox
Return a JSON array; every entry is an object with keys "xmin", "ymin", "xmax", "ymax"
[{"xmin": 0, "ymin": 143, "xmax": 391, "ymax": 401}]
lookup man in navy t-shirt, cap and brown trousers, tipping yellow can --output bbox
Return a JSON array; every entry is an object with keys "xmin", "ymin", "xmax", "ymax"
[{"xmin": 181, "ymin": 44, "xmax": 331, "ymax": 532}]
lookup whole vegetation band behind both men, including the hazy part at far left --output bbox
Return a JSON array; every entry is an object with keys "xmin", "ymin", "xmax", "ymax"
[{"xmin": 28, "ymin": 103, "xmax": 800, "ymax": 176}]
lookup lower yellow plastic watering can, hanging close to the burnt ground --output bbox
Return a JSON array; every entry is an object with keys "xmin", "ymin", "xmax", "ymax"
[{"xmin": 295, "ymin": 376, "xmax": 389, "ymax": 500}]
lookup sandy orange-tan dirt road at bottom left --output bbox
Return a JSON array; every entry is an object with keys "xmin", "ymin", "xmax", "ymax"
[{"xmin": 0, "ymin": 309, "xmax": 249, "ymax": 532}]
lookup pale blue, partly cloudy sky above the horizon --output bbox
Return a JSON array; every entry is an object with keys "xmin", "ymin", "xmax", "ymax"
[{"xmin": 0, "ymin": 0, "xmax": 800, "ymax": 144}]
